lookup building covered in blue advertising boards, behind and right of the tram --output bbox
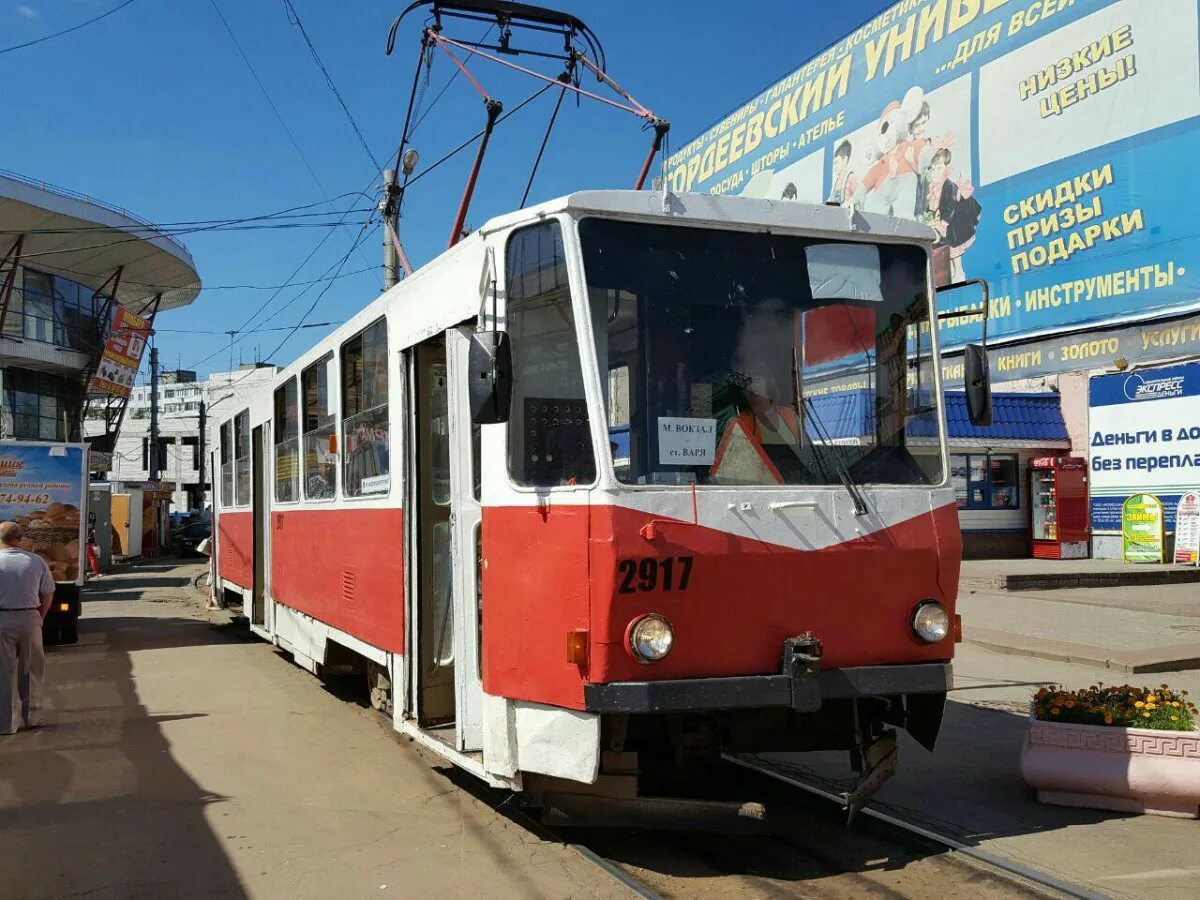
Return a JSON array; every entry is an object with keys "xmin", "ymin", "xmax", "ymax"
[{"xmin": 664, "ymin": 0, "xmax": 1200, "ymax": 557}]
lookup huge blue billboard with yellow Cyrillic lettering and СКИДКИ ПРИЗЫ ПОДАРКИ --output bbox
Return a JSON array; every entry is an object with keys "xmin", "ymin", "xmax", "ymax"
[{"xmin": 666, "ymin": 0, "xmax": 1200, "ymax": 355}]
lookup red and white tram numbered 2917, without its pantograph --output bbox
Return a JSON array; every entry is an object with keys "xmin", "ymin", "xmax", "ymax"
[{"xmin": 214, "ymin": 191, "xmax": 979, "ymax": 816}]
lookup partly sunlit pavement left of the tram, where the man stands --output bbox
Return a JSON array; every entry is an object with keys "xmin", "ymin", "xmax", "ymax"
[{"xmin": 0, "ymin": 560, "xmax": 631, "ymax": 900}]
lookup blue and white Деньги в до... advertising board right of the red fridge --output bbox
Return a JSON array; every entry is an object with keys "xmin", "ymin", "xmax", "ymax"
[{"xmin": 1087, "ymin": 362, "xmax": 1200, "ymax": 533}]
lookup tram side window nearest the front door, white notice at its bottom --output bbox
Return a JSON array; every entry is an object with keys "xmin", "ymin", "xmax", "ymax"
[{"xmin": 342, "ymin": 319, "xmax": 391, "ymax": 497}]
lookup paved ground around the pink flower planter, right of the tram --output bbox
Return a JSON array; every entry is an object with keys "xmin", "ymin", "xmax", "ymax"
[{"xmin": 768, "ymin": 644, "xmax": 1200, "ymax": 900}]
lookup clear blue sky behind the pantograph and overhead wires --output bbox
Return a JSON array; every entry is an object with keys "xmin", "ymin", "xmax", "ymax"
[{"xmin": 0, "ymin": 0, "xmax": 889, "ymax": 376}]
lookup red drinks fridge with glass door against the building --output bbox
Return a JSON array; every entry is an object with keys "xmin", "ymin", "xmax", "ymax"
[{"xmin": 1028, "ymin": 456, "xmax": 1088, "ymax": 559}]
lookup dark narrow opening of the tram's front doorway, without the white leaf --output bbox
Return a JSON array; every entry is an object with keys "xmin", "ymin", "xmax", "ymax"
[{"xmin": 409, "ymin": 336, "xmax": 456, "ymax": 724}]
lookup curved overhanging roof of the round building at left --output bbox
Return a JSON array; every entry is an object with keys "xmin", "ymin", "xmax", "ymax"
[{"xmin": 0, "ymin": 172, "xmax": 200, "ymax": 312}]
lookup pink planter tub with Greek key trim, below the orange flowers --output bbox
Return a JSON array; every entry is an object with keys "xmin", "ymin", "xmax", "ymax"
[{"xmin": 1021, "ymin": 718, "xmax": 1200, "ymax": 818}]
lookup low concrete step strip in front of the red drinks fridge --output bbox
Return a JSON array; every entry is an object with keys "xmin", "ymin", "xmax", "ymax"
[{"xmin": 960, "ymin": 559, "xmax": 1200, "ymax": 590}]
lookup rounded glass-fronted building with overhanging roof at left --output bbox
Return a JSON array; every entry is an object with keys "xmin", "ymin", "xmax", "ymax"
[{"xmin": 0, "ymin": 172, "xmax": 200, "ymax": 460}]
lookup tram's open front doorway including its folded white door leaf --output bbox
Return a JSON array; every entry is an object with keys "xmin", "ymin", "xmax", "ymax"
[{"xmin": 407, "ymin": 329, "xmax": 482, "ymax": 752}]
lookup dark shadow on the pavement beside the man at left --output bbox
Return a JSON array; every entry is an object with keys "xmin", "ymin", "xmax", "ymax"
[{"xmin": 0, "ymin": 584, "xmax": 246, "ymax": 898}]
